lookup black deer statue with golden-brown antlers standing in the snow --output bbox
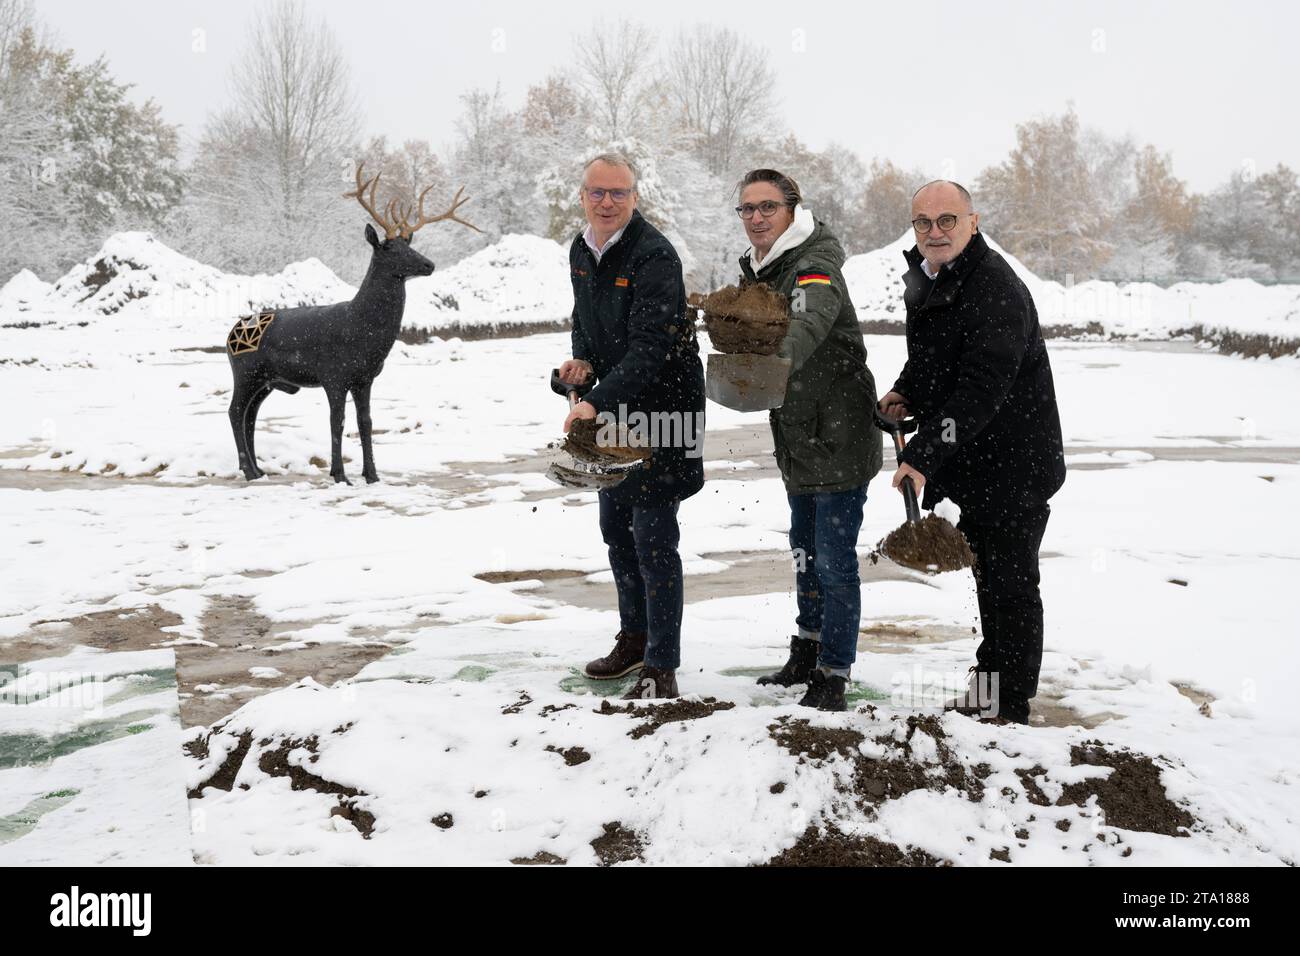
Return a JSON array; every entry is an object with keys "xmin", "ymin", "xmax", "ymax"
[{"xmin": 226, "ymin": 163, "xmax": 482, "ymax": 484}]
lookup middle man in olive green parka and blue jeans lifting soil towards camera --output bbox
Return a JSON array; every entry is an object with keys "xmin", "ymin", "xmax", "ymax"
[{"xmin": 736, "ymin": 169, "xmax": 883, "ymax": 710}]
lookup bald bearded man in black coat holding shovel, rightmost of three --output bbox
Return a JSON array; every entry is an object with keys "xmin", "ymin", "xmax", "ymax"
[{"xmin": 880, "ymin": 181, "xmax": 1065, "ymax": 723}]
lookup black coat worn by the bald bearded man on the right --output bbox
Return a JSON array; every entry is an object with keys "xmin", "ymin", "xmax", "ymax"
[{"xmin": 893, "ymin": 233, "xmax": 1065, "ymax": 522}]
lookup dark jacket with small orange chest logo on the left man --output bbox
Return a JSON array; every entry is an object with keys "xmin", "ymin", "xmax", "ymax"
[{"xmin": 569, "ymin": 211, "xmax": 705, "ymax": 507}]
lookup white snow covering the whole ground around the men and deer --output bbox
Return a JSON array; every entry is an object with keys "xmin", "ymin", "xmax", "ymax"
[{"xmin": 0, "ymin": 233, "xmax": 1300, "ymax": 866}]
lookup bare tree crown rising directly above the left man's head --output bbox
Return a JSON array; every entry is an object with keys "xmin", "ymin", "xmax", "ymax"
[{"xmin": 573, "ymin": 20, "xmax": 655, "ymax": 139}]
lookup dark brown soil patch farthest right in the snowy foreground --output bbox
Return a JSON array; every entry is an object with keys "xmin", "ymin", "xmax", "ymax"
[{"xmin": 1057, "ymin": 741, "xmax": 1196, "ymax": 836}]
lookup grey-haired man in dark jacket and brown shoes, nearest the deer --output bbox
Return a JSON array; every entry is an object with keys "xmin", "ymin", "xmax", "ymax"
[{"xmin": 560, "ymin": 153, "xmax": 705, "ymax": 700}]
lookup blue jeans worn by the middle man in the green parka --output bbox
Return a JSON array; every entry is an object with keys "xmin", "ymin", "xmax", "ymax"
[{"xmin": 787, "ymin": 484, "xmax": 867, "ymax": 678}]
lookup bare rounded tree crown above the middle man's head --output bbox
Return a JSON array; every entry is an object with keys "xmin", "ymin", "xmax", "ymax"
[{"xmin": 660, "ymin": 23, "xmax": 776, "ymax": 176}]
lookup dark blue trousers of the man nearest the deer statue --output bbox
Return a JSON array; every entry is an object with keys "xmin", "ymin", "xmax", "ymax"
[{"xmin": 599, "ymin": 492, "xmax": 683, "ymax": 670}]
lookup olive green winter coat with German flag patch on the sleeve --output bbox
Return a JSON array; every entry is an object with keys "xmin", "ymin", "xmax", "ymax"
[{"xmin": 740, "ymin": 222, "xmax": 883, "ymax": 494}]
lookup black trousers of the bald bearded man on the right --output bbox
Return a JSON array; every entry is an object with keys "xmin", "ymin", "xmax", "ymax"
[{"xmin": 957, "ymin": 503, "xmax": 1052, "ymax": 704}]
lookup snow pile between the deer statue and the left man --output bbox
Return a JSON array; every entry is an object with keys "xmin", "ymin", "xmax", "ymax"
[{"xmin": 402, "ymin": 235, "xmax": 573, "ymax": 330}]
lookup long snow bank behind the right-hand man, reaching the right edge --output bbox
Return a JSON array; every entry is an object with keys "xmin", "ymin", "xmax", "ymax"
[{"xmin": 844, "ymin": 232, "xmax": 1300, "ymax": 351}]
